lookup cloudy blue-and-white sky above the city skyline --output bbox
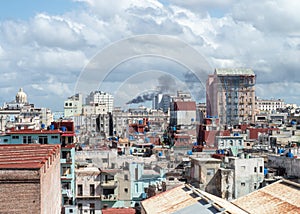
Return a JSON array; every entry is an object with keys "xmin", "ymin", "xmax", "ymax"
[{"xmin": 0, "ymin": 0, "xmax": 300, "ymax": 111}]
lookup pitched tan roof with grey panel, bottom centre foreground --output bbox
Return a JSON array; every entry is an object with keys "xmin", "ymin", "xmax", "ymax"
[{"xmin": 141, "ymin": 185, "xmax": 246, "ymax": 214}]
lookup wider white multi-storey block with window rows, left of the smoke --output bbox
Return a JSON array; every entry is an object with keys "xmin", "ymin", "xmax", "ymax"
[{"xmin": 85, "ymin": 91, "xmax": 114, "ymax": 112}]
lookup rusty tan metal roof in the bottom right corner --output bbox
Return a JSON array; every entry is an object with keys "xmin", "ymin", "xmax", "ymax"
[{"xmin": 233, "ymin": 180, "xmax": 300, "ymax": 214}]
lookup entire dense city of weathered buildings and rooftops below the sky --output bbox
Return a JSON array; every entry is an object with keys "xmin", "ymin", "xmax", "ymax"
[{"xmin": 0, "ymin": 68, "xmax": 300, "ymax": 213}]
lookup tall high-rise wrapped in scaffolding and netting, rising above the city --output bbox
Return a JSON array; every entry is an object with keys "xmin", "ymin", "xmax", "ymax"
[{"xmin": 206, "ymin": 68, "xmax": 256, "ymax": 125}]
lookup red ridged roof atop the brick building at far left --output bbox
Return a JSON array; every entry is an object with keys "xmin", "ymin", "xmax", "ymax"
[{"xmin": 0, "ymin": 144, "xmax": 60, "ymax": 169}]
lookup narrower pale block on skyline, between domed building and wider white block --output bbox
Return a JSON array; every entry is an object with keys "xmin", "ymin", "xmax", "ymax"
[{"xmin": 64, "ymin": 94, "xmax": 82, "ymax": 118}]
